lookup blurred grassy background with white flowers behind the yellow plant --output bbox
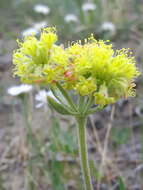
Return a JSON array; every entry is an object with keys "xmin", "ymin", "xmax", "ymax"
[{"xmin": 0, "ymin": 0, "xmax": 143, "ymax": 190}]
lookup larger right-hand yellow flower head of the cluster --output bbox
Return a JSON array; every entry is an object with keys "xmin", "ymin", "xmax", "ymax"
[{"xmin": 66, "ymin": 36, "xmax": 139, "ymax": 105}]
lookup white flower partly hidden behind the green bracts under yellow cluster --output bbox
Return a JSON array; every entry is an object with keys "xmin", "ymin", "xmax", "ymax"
[{"xmin": 35, "ymin": 90, "xmax": 58, "ymax": 108}]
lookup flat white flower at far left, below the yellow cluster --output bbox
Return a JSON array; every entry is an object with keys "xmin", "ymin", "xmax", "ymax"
[{"xmin": 7, "ymin": 84, "xmax": 33, "ymax": 96}]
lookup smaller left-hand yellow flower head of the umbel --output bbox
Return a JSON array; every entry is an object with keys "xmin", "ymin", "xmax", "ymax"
[{"xmin": 13, "ymin": 27, "xmax": 67, "ymax": 84}]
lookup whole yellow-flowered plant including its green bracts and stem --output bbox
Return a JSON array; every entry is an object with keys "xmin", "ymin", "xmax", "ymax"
[{"xmin": 13, "ymin": 28, "xmax": 139, "ymax": 190}]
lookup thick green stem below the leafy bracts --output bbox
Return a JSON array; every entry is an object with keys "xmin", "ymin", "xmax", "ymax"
[{"xmin": 76, "ymin": 116, "xmax": 93, "ymax": 190}]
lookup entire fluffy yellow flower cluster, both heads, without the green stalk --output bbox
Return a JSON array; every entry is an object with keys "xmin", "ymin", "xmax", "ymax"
[{"xmin": 13, "ymin": 28, "xmax": 139, "ymax": 105}]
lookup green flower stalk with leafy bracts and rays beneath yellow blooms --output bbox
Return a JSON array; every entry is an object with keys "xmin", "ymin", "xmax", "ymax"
[{"xmin": 48, "ymin": 84, "xmax": 95, "ymax": 190}]
